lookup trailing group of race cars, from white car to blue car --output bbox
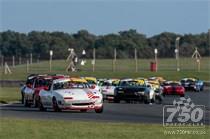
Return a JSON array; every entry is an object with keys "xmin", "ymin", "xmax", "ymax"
[{"xmin": 99, "ymin": 77, "xmax": 204, "ymax": 103}]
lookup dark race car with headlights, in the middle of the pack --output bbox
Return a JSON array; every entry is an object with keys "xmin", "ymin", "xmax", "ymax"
[{"xmin": 114, "ymin": 79, "xmax": 155, "ymax": 103}]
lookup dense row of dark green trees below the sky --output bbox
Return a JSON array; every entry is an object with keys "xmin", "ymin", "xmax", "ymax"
[{"xmin": 0, "ymin": 29, "xmax": 210, "ymax": 59}]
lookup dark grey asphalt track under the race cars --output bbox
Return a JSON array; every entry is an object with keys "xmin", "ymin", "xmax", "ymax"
[{"xmin": 0, "ymin": 90, "xmax": 210, "ymax": 124}]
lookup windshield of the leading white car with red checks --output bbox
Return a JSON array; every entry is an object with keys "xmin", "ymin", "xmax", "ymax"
[{"xmin": 53, "ymin": 81, "xmax": 90, "ymax": 90}]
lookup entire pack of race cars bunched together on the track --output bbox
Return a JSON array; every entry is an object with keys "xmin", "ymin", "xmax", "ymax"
[{"xmin": 21, "ymin": 74, "xmax": 204, "ymax": 113}]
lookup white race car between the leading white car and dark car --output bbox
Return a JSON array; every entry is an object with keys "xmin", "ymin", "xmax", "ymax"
[{"xmin": 100, "ymin": 79, "xmax": 119, "ymax": 100}]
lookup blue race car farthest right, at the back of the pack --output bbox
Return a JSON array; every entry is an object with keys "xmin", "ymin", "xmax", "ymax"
[{"xmin": 180, "ymin": 78, "xmax": 204, "ymax": 92}]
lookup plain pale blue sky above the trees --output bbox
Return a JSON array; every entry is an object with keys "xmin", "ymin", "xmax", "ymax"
[{"xmin": 0, "ymin": 0, "xmax": 210, "ymax": 36}]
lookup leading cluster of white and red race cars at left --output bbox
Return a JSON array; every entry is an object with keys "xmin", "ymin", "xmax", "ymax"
[{"xmin": 21, "ymin": 75, "xmax": 103, "ymax": 113}]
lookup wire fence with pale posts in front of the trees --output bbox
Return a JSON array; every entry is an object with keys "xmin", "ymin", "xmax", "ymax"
[{"xmin": 0, "ymin": 51, "xmax": 210, "ymax": 73}]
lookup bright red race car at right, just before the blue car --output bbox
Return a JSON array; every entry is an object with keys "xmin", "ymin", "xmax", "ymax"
[{"xmin": 163, "ymin": 81, "xmax": 185, "ymax": 97}]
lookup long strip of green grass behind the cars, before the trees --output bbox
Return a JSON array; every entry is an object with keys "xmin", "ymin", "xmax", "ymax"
[{"xmin": 0, "ymin": 57, "xmax": 210, "ymax": 80}]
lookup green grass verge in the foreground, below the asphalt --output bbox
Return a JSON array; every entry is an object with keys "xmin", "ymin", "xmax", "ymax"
[{"xmin": 0, "ymin": 118, "xmax": 209, "ymax": 139}]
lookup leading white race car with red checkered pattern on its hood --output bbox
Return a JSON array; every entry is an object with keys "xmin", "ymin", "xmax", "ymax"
[{"xmin": 39, "ymin": 78, "xmax": 103, "ymax": 113}]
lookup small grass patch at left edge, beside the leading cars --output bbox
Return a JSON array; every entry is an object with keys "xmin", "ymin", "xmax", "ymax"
[{"xmin": 0, "ymin": 87, "xmax": 21, "ymax": 103}]
